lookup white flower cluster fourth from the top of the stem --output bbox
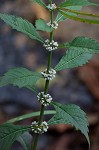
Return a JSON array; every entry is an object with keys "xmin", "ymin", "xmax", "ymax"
[{"xmin": 41, "ymin": 69, "xmax": 56, "ymax": 80}]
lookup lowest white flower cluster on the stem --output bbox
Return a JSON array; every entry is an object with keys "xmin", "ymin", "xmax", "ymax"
[{"xmin": 31, "ymin": 121, "xmax": 48, "ymax": 134}]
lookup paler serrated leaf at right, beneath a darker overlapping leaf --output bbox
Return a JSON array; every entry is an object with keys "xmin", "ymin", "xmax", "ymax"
[{"xmin": 55, "ymin": 49, "xmax": 92, "ymax": 71}]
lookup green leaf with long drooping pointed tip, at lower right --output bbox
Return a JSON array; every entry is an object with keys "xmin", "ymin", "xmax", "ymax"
[{"xmin": 48, "ymin": 102, "xmax": 90, "ymax": 145}]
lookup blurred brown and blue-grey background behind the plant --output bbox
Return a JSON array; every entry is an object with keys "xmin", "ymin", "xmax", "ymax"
[{"xmin": 0, "ymin": 0, "xmax": 99, "ymax": 150}]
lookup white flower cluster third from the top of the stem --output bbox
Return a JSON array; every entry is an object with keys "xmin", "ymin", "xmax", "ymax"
[{"xmin": 43, "ymin": 39, "xmax": 58, "ymax": 51}]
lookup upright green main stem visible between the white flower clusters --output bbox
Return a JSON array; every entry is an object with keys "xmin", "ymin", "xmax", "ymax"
[{"xmin": 33, "ymin": 0, "xmax": 53, "ymax": 150}]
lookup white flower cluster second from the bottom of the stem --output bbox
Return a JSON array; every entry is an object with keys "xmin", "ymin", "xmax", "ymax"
[{"xmin": 37, "ymin": 92, "xmax": 52, "ymax": 106}]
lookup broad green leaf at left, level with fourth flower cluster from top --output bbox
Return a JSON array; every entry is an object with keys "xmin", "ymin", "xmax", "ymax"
[{"xmin": 0, "ymin": 68, "xmax": 42, "ymax": 90}]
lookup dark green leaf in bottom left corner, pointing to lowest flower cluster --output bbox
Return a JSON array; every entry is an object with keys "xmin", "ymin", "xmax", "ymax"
[{"xmin": 0, "ymin": 123, "xmax": 30, "ymax": 150}]
